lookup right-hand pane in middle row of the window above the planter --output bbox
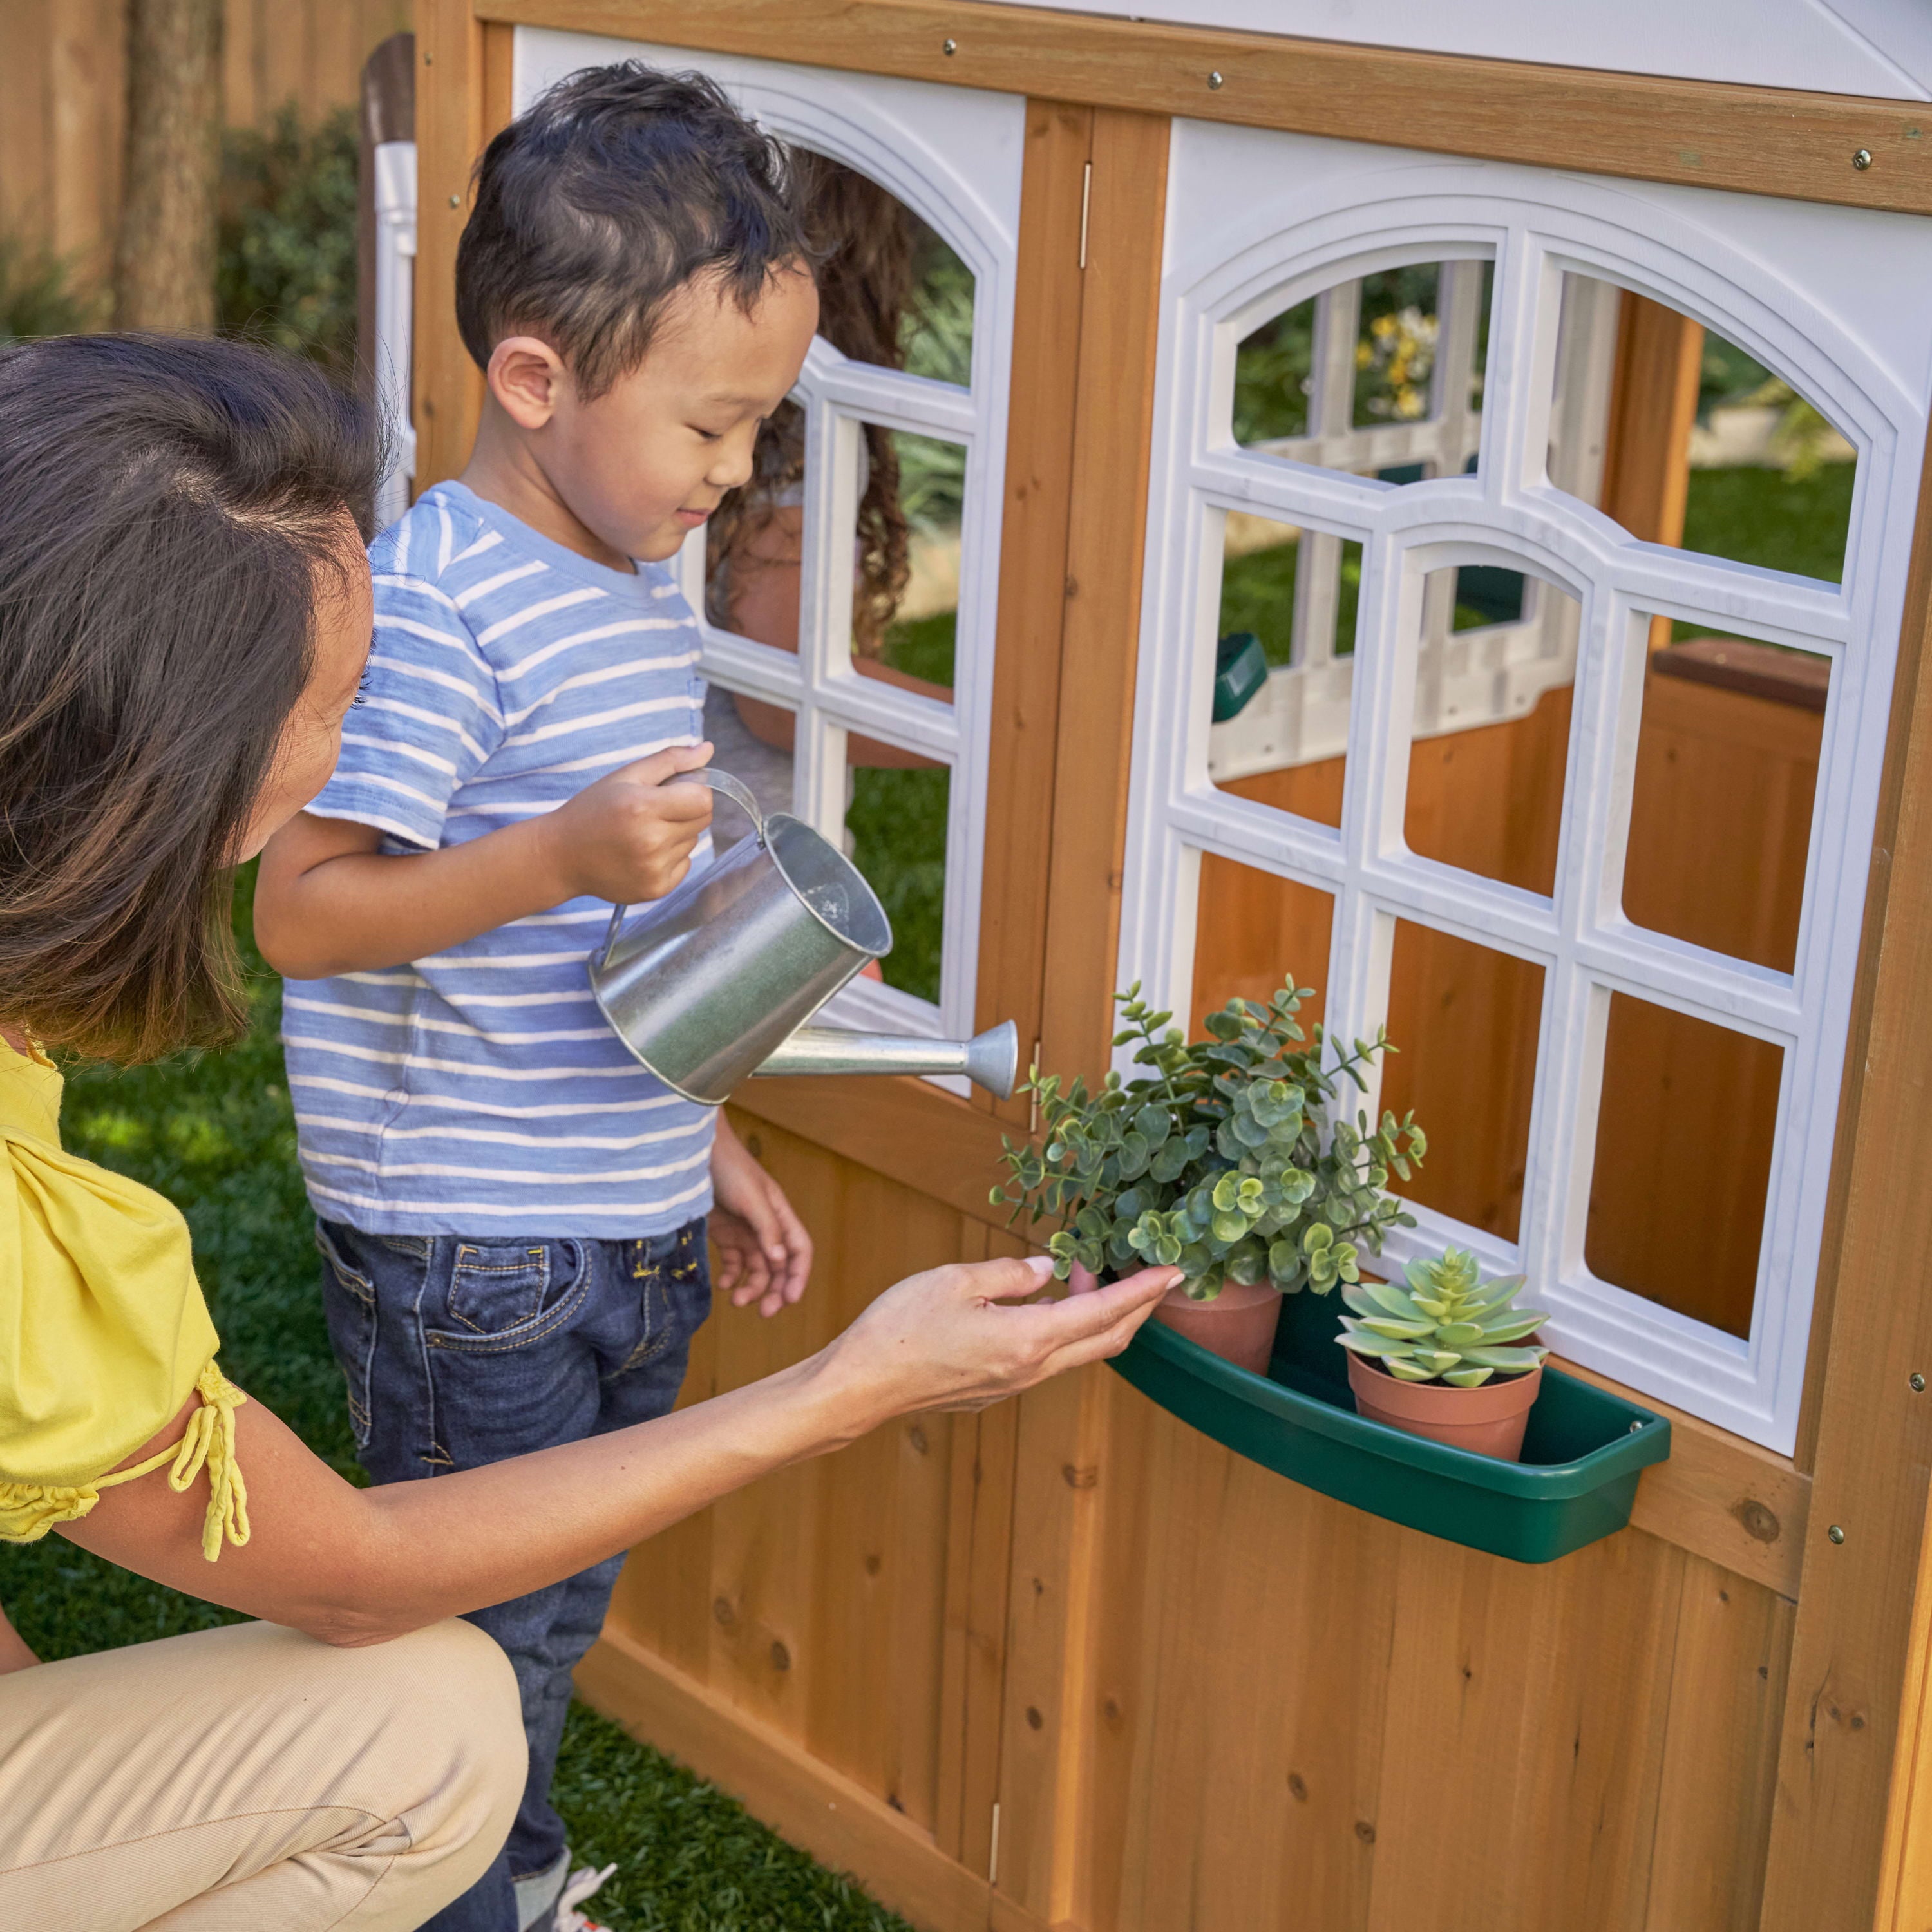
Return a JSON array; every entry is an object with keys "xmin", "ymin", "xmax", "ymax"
[{"xmin": 1623, "ymin": 626, "xmax": 1832, "ymax": 972}]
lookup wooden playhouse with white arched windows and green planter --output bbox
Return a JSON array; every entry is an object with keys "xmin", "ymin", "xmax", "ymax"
[{"xmin": 404, "ymin": 0, "xmax": 1932, "ymax": 1932}]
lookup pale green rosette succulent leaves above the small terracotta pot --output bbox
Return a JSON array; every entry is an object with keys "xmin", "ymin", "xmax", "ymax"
[{"xmin": 1335, "ymin": 1248, "xmax": 1549, "ymax": 1389}]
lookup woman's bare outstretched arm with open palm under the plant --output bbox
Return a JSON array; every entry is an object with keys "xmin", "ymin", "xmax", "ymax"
[{"xmin": 62, "ymin": 1262, "xmax": 1177, "ymax": 1644}]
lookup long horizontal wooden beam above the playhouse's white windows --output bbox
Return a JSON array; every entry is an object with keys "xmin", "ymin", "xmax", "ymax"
[{"xmin": 475, "ymin": 0, "xmax": 1932, "ymax": 214}]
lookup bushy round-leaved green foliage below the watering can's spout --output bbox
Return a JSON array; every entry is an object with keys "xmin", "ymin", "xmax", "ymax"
[{"xmin": 993, "ymin": 980, "xmax": 1428, "ymax": 1300}]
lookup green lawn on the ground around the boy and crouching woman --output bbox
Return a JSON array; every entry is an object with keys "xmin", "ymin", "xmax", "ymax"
[{"xmin": 0, "ymin": 877, "xmax": 923, "ymax": 1932}]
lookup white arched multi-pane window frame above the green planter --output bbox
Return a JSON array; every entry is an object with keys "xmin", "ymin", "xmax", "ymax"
[{"xmin": 1119, "ymin": 122, "xmax": 1932, "ymax": 1453}]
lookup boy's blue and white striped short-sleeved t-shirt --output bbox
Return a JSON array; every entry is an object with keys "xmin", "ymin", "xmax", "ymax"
[{"xmin": 282, "ymin": 483, "xmax": 715, "ymax": 1238}]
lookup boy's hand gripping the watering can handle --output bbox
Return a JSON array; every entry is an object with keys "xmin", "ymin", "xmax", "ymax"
[{"xmin": 533, "ymin": 744, "xmax": 711, "ymax": 904}]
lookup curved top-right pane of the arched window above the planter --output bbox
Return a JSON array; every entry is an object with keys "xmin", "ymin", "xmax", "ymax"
[{"xmin": 1549, "ymin": 274, "xmax": 1857, "ymax": 583}]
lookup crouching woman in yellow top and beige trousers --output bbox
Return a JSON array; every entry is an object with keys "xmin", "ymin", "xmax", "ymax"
[{"xmin": 0, "ymin": 336, "xmax": 1173, "ymax": 1932}]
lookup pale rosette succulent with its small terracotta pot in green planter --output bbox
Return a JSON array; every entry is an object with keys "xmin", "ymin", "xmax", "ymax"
[{"xmin": 1335, "ymin": 1248, "xmax": 1549, "ymax": 1463}]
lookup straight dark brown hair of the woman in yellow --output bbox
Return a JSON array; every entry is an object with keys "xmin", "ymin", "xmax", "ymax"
[{"xmin": 0, "ymin": 336, "xmax": 381, "ymax": 1061}]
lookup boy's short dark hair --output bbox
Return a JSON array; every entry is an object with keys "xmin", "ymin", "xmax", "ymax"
[{"xmin": 456, "ymin": 60, "xmax": 811, "ymax": 398}]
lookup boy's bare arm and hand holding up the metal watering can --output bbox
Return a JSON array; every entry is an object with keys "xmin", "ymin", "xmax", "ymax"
[{"xmin": 255, "ymin": 744, "xmax": 711, "ymax": 980}]
